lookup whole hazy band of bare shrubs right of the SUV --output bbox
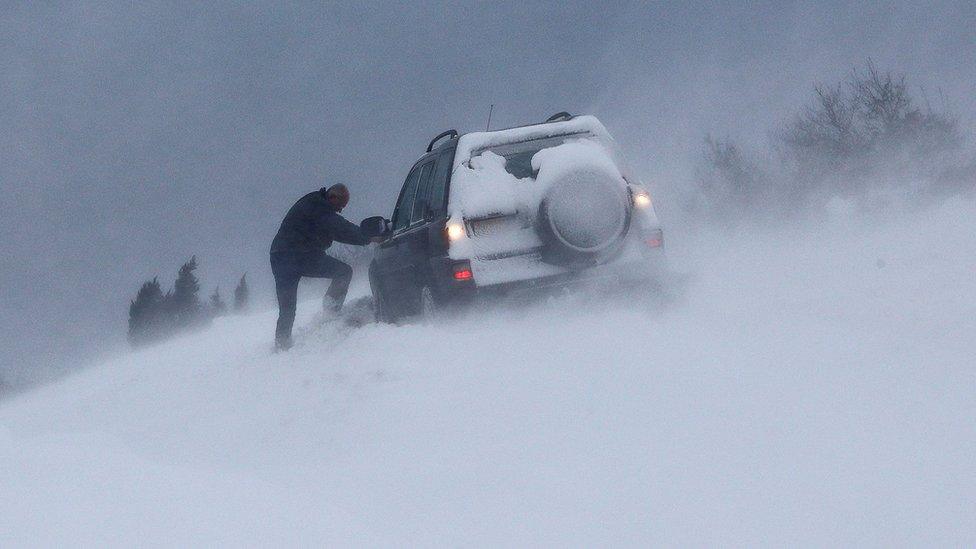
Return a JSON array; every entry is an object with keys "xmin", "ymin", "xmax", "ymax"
[{"xmin": 695, "ymin": 60, "xmax": 976, "ymax": 223}]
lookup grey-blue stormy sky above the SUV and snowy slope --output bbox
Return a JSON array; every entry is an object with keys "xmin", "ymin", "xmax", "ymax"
[{"xmin": 0, "ymin": 1, "xmax": 976, "ymax": 386}]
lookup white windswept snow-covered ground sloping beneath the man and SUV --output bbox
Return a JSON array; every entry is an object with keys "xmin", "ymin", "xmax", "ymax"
[{"xmin": 0, "ymin": 197, "xmax": 976, "ymax": 547}]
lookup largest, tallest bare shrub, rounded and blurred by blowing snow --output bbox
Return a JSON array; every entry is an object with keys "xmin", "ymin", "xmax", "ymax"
[{"xmin": 779, "ymin": 61, "xmax": 962, "ymax": 197}]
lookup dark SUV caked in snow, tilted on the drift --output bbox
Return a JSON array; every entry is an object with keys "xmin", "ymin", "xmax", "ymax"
[{"xmin": 369, "ymin": 113, "xmax": 663, "ymax": 322}]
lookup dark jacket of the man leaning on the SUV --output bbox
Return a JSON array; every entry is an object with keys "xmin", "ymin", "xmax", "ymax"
[{"xmin": 271, "ymin": 189, "xmax": 369, "ymax": 253}]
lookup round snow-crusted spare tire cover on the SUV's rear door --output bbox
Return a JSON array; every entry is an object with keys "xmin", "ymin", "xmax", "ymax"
[{"xmin": 539, "ymin": 168, "xmax": 630, "ymax": 263}]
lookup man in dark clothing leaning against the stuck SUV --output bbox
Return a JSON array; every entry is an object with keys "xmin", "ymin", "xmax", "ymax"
[{"xmin": 271, "ymin": 184, "xmax": 381, "ymax": 351}]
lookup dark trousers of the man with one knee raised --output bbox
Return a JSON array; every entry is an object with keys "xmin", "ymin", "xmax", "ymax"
[{"xmin": 271, "ymin": 252, "xmax": 352, "ymax": 345}]
